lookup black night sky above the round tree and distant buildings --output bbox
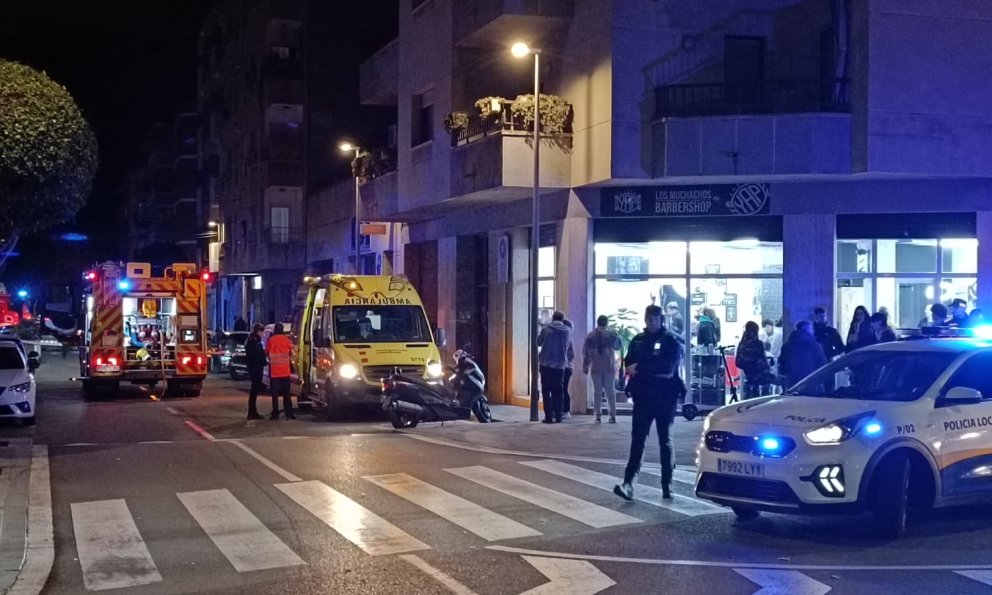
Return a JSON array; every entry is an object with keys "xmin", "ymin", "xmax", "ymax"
[{"xmin": 0, "ymin": 0, "xmax": 398, "ymax": 286}]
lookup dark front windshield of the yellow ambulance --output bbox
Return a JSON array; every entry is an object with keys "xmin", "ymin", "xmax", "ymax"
[{"xmin": 333, "ymin": 305, "xmax": 431, "ymax": 343}]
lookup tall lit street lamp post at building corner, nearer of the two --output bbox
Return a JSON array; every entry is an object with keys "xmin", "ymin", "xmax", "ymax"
[{"xmin": 510, "ymin": 41, "xmax": 554, "ymax": 421}]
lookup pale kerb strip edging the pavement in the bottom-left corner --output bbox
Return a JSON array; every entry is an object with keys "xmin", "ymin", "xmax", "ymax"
[{"xmin": 7, "ymin": 446, "xmax": 55, "ymax": 595}]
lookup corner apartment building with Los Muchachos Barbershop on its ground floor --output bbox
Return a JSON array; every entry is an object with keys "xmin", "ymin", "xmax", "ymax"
[{"xmin": 362, "ymin": 0, "xmax": 992, "ymax": 411}]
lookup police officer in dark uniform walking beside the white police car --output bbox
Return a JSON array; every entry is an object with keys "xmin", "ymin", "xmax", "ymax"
[{"xmin": 613, "ymin": 304, "xmax": 685, "ymax": 500}]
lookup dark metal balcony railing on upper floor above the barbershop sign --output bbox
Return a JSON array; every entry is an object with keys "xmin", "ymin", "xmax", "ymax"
[{"xmin": 655, "ymin": 78, "xmax": 851, "ymax": 118}]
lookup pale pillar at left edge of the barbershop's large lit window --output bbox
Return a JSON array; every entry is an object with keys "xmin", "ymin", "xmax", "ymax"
[{"xmin": 555, "ymin": 217, "xmax": 592, "ymax": 413}]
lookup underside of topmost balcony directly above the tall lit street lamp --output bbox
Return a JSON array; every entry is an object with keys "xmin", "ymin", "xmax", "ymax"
[{"xmin": 452, "ymin": 0, "xmax": 574, "ymax": 47}]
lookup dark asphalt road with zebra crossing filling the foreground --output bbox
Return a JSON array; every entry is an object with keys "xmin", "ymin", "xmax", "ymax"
[{"xmin": 0, "ymin": 353, "xmax": 992, "ymax": 595}]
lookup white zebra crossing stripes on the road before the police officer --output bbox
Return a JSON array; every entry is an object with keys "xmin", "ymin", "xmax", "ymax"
[{"xmin": 70, "ymin": 460, "xmax": 712, "ymax": 591}]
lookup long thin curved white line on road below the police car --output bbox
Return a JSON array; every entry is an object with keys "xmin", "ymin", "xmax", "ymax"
[{"xmin": 486, "ymin": 545, "xmax": 992, "ymax": 572}]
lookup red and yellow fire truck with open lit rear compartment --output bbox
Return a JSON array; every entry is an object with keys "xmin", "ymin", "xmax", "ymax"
[{"xmin": 79, "ymin": 262, "xmax": 211, "ymax": 397}]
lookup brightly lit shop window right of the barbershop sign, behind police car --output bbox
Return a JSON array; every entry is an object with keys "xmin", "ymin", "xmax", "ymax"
[{"xmin": 837, "ymin": 238, "xmax": 978, "ymax": 333}]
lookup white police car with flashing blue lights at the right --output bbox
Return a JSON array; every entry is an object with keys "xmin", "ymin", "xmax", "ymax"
[{"xmin": 696, "ymin": 327, "xmax": 992, "ymax": 537}]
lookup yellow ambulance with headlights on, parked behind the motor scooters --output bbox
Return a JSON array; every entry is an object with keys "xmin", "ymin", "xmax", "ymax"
[{"xmin": 292, "ymin": 275, "xmax": 444, "ymax": 417}]
